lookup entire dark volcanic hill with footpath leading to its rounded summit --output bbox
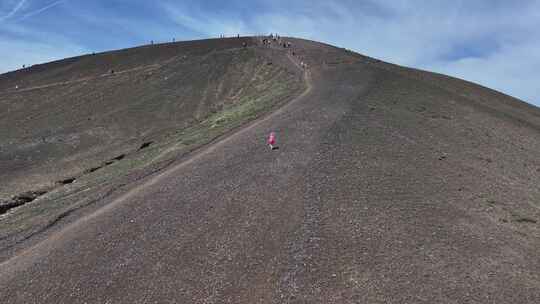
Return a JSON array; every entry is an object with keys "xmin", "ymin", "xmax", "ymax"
[{"xmin": 0, "ymin": 37, "xmax": 540, "ymax": 303}]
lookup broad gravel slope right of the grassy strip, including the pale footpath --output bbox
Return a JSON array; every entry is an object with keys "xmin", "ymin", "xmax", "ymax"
[{"xmin": 0, "ymin": 39, "xmax": 540, "ymax": 303}]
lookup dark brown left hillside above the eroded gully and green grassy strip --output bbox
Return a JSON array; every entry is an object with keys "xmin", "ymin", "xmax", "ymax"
[{"xmin": 0, "ymin": 38, "xmax": 301, "ymax": 199}]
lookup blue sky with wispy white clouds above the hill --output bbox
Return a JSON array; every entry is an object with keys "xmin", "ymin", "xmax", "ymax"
[{"xmin": 0, "ymin": 0, "xmax": 540, "ymax": 106}]
